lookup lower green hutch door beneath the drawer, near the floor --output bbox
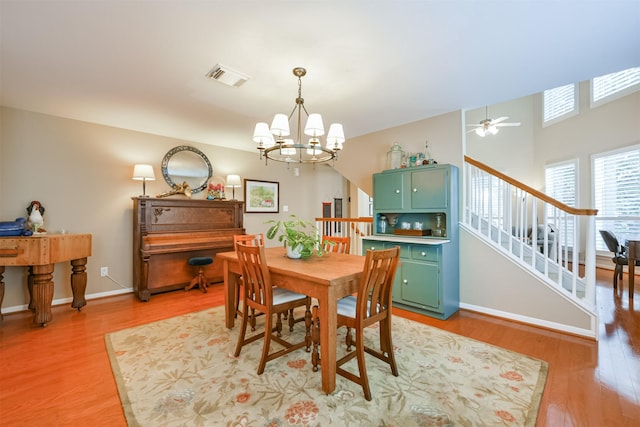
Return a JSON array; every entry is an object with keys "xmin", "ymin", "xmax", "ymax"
[{"xmin": 394, "ymin": 261, "xmax": 440, "ymax": 310}]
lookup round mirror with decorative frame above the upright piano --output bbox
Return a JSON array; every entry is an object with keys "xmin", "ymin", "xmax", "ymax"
[{"xmin": 162, "ymin": 145, "xmax": 213, "ymax": 193}]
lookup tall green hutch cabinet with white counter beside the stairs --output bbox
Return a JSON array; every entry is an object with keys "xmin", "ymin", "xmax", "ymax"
[{"xmin": 363, "ymin": 165, "xmax": 460, "ymax": 319}]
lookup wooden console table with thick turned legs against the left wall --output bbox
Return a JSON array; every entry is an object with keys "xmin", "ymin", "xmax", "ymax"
[{"xmin": 0, "ymin": 234, "xmax": 91, "ymax": 326}]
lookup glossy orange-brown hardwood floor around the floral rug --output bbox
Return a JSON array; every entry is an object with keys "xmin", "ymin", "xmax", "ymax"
[{"xmin": 0, "ymin": 270, "xmax": 640, "ymax": 427}]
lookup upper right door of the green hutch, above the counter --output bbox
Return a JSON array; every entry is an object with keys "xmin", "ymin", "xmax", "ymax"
[{"xmin": 411, "ymin": 167, "xmax": 449, "ymax": 211}]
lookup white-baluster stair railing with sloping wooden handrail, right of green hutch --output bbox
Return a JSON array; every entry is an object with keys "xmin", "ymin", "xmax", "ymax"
[{"xmin": 461, "ymin": 156, "xmax": 597, "ymax": 325}]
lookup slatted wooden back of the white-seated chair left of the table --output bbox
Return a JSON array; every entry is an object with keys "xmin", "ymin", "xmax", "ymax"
[{"xmin": 236, "ymin": 243, "xmax": 273, "ymax": 313}]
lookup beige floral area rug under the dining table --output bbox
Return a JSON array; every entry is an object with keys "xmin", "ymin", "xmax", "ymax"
[{"xmin": 105, "ymin": 307, "xmax": 547, "ymax": 427}]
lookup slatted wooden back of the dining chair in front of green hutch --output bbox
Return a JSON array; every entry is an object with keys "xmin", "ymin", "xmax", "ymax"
[{"xmin": 356, "ymin": 246, "xmax": 400, "ymax": 321}]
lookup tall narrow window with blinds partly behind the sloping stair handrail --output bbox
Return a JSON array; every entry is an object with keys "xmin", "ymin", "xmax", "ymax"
[{"xmin": 544, "ymin": 159, "xmax": 579, "ymax": 246}]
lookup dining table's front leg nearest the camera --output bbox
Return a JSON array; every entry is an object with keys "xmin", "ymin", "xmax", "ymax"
[{"xmin": 318, "ymin": 287, "xmax": 338, "ymax": 394}]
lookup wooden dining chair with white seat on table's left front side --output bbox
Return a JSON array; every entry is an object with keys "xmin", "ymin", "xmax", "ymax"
[{"xmin": 234, "ymin": 243, "xmax": 311, "ymax": 375}]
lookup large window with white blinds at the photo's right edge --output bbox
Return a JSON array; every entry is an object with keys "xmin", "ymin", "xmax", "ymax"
[{"xmin": 592, "ymin": 145, "xmax": 640, "ymax": 252}]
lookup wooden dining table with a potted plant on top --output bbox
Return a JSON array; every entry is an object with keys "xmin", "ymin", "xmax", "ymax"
[{"xmin": 216, "ymin": 247, "xmax": 364, "ymax": 394}]
